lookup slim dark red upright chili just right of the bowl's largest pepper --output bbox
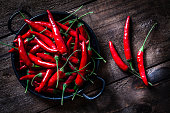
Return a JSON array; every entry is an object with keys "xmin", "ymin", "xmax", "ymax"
[{"xmin": 73, "ymin": 29, "xmax": 80, "ymax": 58}]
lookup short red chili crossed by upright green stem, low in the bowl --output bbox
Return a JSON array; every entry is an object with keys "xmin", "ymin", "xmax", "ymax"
[{"xmin": 47, "ymin": 70, "xmax": 66, "ymax": 87}]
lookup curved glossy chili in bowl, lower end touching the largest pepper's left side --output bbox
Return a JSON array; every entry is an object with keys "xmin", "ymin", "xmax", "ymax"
[{"xmin": 34, "ymin": 37, "xmax": 59, "ymax": 53}]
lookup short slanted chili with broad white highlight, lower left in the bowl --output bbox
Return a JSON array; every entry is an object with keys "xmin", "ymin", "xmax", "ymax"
[{"xmin": 35, "ymin": 69, "xmax": 54, "ymax": 92}]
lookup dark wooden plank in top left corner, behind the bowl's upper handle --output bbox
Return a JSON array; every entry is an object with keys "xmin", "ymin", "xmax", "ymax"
[{"xmin": 0, "ymin": 0, "xmax": 94, "ymax": 37}]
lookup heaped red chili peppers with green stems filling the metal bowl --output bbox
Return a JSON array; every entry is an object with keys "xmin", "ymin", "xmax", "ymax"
[{"xmin": 6, "ymin": 6, "xmax": 105, "ymax": 104}]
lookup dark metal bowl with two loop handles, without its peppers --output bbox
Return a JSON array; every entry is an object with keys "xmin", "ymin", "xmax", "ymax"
[{"xmin": 8, "ymin": 11, "xmax": 105, "ymax": 100}]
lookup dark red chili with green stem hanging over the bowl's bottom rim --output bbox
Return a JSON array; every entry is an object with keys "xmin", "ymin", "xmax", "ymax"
[{"xmin": 61, "ymin": 73, "xmax": 77, "ymax": 105}]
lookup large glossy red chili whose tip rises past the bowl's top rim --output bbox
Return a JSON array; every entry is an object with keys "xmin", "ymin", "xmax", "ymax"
[{"xmin": 47, "ymin": 10, "xmax": 67, "ymax": 54}]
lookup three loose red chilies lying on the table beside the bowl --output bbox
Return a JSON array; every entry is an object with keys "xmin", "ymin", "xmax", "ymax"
[{"xmin": 109, "ymin": 16, "xmax": 157, "ymax": 86}]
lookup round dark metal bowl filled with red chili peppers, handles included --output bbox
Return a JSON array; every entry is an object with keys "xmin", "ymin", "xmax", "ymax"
[{"xmin": 8, "ymin": 6, "xmax": 105, "ymax": 104}]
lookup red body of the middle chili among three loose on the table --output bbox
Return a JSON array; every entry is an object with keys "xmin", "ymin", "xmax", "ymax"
[{"xmin": 123, "ymin": 16, "xmax": 132, "ymax": 61}]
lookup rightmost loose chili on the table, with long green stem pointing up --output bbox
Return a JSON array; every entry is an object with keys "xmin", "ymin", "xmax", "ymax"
[{"xmin": 137, "ymin": 23, "xmax": 157, "ymax": 86}]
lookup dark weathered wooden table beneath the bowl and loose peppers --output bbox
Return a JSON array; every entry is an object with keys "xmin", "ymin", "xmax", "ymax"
[{"xmin": 0, "ymin": 0, "xmax": 170, "ymax": 113}]
